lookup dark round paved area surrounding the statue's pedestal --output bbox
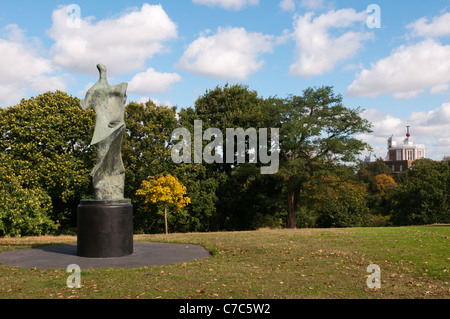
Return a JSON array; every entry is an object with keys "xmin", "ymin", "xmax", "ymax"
[{"xmin": 0, "ymin": 241, "xmax": 211, "ymax": 269}]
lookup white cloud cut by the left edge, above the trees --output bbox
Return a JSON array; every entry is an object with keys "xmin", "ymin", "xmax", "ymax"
[{"xmin": 0, "ymin": 25, "xmax": 66, "ymax": 105}]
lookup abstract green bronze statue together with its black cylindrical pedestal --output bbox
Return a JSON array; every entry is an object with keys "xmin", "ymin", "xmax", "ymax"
[{"xmin": 77, "ymin": 64, "xmax": 133, "ymax": 257}]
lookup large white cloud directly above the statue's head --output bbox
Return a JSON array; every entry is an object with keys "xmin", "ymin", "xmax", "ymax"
[{"xmin": 48, "ymin": 4, "xmax": 177, "ymax": 74}]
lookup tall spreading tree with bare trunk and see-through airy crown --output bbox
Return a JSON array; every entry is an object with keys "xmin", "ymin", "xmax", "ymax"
[{"xmin": 272, "ymin": 86, "xmax": 371, "ymax": 228}]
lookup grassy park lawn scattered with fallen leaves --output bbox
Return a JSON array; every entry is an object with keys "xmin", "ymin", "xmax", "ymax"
[{"xmin": 0, "ymin": 225, "xmax": 450, "ymax": 299}]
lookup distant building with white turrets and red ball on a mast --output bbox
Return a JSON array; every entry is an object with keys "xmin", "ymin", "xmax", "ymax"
[{"xmin": 384, "ymin": 126, "xmax": 425, "ymax": 173}]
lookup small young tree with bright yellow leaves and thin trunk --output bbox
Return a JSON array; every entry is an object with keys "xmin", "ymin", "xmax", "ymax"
[{"xmin": 136, "ymin": 174, "xmax": 191, "ymax": 234}]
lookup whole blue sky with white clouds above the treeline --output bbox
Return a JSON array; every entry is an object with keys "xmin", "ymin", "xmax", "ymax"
[{"xmin": 0, "ymin": 0, "xmax": 450, "ymax": 160}]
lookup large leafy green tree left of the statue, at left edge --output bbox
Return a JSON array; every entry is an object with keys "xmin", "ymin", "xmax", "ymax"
[{"xmin": 0, "ymin": 91, "xmax": 95, "ymax": 229}]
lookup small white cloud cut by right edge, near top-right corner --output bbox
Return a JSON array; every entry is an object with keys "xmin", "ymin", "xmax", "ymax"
[{"xmin": 407, "ymin": 13, "xmax": 450, "ymax": 37}]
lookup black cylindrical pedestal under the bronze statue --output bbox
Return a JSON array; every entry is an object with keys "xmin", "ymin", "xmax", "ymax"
[{"xmin": 77, "ymin": 199, "xmax": 133, "ymax": 257}]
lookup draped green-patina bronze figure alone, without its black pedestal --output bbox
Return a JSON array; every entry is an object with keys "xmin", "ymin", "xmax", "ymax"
[{"xmin": 80, "ymin": 64, "xmax": 128, "ymax": 200}]
